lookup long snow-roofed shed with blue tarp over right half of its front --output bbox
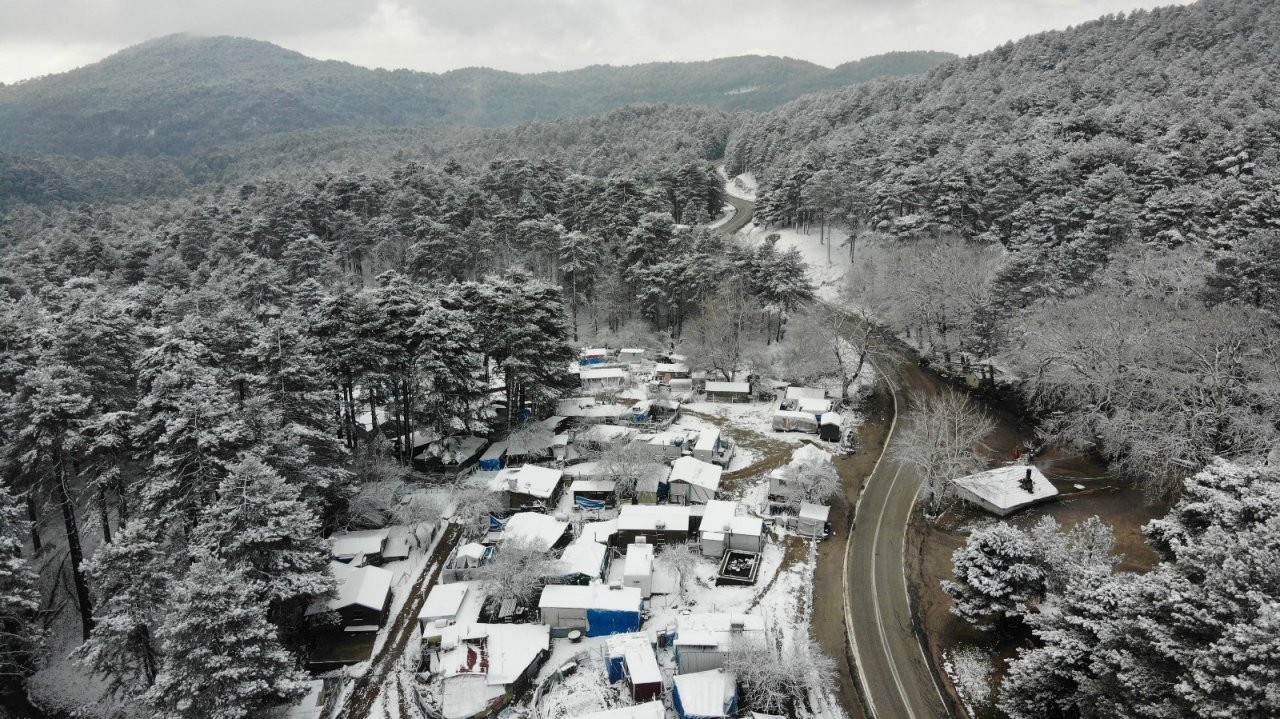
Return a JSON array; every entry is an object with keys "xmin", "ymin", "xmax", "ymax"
[{"xmin": 538, "ymin": 585, "xmax": 644, "ymax": 637}]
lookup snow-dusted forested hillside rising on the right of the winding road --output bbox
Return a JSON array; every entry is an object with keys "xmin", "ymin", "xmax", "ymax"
[{"xmin": 727, "ymin": 0, "xmax": 1280, "ymax": 491}]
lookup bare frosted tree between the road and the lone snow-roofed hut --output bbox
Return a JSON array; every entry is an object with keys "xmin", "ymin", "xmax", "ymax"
[{"xmin": 893, "ymin": 390, "xmax": 996, "ymax": 518}]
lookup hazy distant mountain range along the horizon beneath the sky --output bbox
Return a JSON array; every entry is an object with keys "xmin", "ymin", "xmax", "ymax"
[{"xmin": 0, "ymin": 35, "xmax": 954, "ymax": 156}]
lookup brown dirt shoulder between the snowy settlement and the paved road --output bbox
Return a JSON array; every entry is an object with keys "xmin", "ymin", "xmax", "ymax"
[{"xmin": 810, "ymin": 386, "xmax": 893, "ymax": 719}]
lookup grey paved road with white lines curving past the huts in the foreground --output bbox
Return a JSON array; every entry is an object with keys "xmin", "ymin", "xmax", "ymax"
[{"xmin": 845, "ymin": 357, "xmax": 948, "ymax": 719}]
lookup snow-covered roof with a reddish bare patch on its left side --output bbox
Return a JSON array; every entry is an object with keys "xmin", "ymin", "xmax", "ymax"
[{"xmin": 440, "ymin": 624, "xmax": 552, "ymax": 686}]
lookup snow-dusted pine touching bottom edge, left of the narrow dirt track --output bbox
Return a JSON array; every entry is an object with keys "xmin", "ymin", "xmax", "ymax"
[{"xmin": 146, "ymin": 558, "xmax": 306, "ymax": 719}]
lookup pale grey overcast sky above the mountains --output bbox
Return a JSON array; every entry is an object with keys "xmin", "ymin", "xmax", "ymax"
[{"xmin": 0, "ymin": 0, "xmax": 1198, "ymax": 82}]
